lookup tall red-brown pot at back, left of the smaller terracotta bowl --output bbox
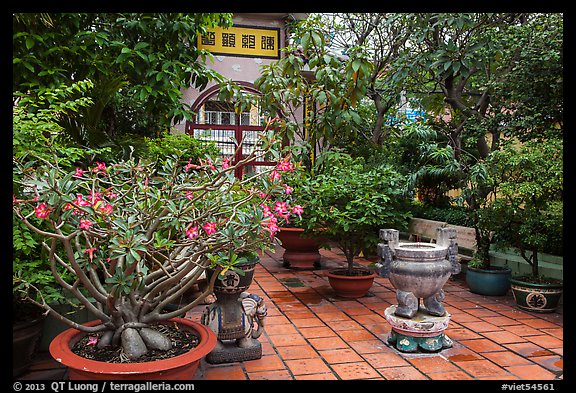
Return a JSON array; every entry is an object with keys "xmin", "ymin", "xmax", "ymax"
[{"xmin": 276, "ymin": 228, "xmax": 321, "ymax": 270}]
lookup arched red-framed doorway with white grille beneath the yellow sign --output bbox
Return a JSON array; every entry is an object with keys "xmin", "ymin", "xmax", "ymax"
[{"xmin": 185, "ymin": 82, "xmax": 276, "ymax": 178}]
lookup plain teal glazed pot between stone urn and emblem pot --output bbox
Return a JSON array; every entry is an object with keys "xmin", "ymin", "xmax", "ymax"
[{"xmin": 466, "ymin": 266, "xmax": 512, "ymax": 296}]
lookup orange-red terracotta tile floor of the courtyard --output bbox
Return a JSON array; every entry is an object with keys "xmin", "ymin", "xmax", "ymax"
[{"xmin": 16, "ymin": 248, "xmax": 563, "ymax": 381}]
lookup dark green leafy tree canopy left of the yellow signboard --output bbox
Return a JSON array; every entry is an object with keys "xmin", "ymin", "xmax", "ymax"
[{"xmin": 12, "ymin": 13, "xmax": 232, "ymax": 147}]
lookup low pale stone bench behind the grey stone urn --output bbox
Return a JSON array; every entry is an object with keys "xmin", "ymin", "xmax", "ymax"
[{"xmin": 406, "ymin": 217, "xmax": 477, "ymax": 263}]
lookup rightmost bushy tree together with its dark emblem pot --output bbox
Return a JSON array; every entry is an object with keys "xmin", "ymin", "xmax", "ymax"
[{"xmin": 486, "ymin": 138, "xmax": 563, "ymax": 312}]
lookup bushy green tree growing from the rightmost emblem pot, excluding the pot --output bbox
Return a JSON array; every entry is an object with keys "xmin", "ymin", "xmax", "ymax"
[{"xmin": 481, "ymin": 138, "xmax": 563, "ymax": 280}]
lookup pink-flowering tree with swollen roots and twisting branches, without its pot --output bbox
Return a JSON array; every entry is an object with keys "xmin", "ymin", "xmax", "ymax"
[{"xmin": 13, "ymin": 121, "xmax": 302, "ymax": 359}]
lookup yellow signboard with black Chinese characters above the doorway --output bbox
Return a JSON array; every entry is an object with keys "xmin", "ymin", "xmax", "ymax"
[{"xmin": 198, "ymin": 26, "xmax": 280, "ymax": 59}]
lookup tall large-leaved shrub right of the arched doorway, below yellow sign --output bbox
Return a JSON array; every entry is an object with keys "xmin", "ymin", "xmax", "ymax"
[{"xmin": 254, "ymin": 19, "xmax": 373, "ymax": 168}]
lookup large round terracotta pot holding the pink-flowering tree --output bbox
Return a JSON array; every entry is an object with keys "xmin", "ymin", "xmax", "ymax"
[{"xmin": 50, "ymin": 318, "xmax": 216, "ymax": 380}]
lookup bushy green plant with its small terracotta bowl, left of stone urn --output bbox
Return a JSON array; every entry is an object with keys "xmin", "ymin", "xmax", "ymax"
[{"xmin": 301, "ymin": 150, "xmax": 409, "ymax": 298}]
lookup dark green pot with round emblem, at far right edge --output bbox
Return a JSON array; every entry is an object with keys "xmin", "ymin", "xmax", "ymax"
[{"xmin": 510, "ymin": 278, "xmax": 563, "ymax": 313}]
